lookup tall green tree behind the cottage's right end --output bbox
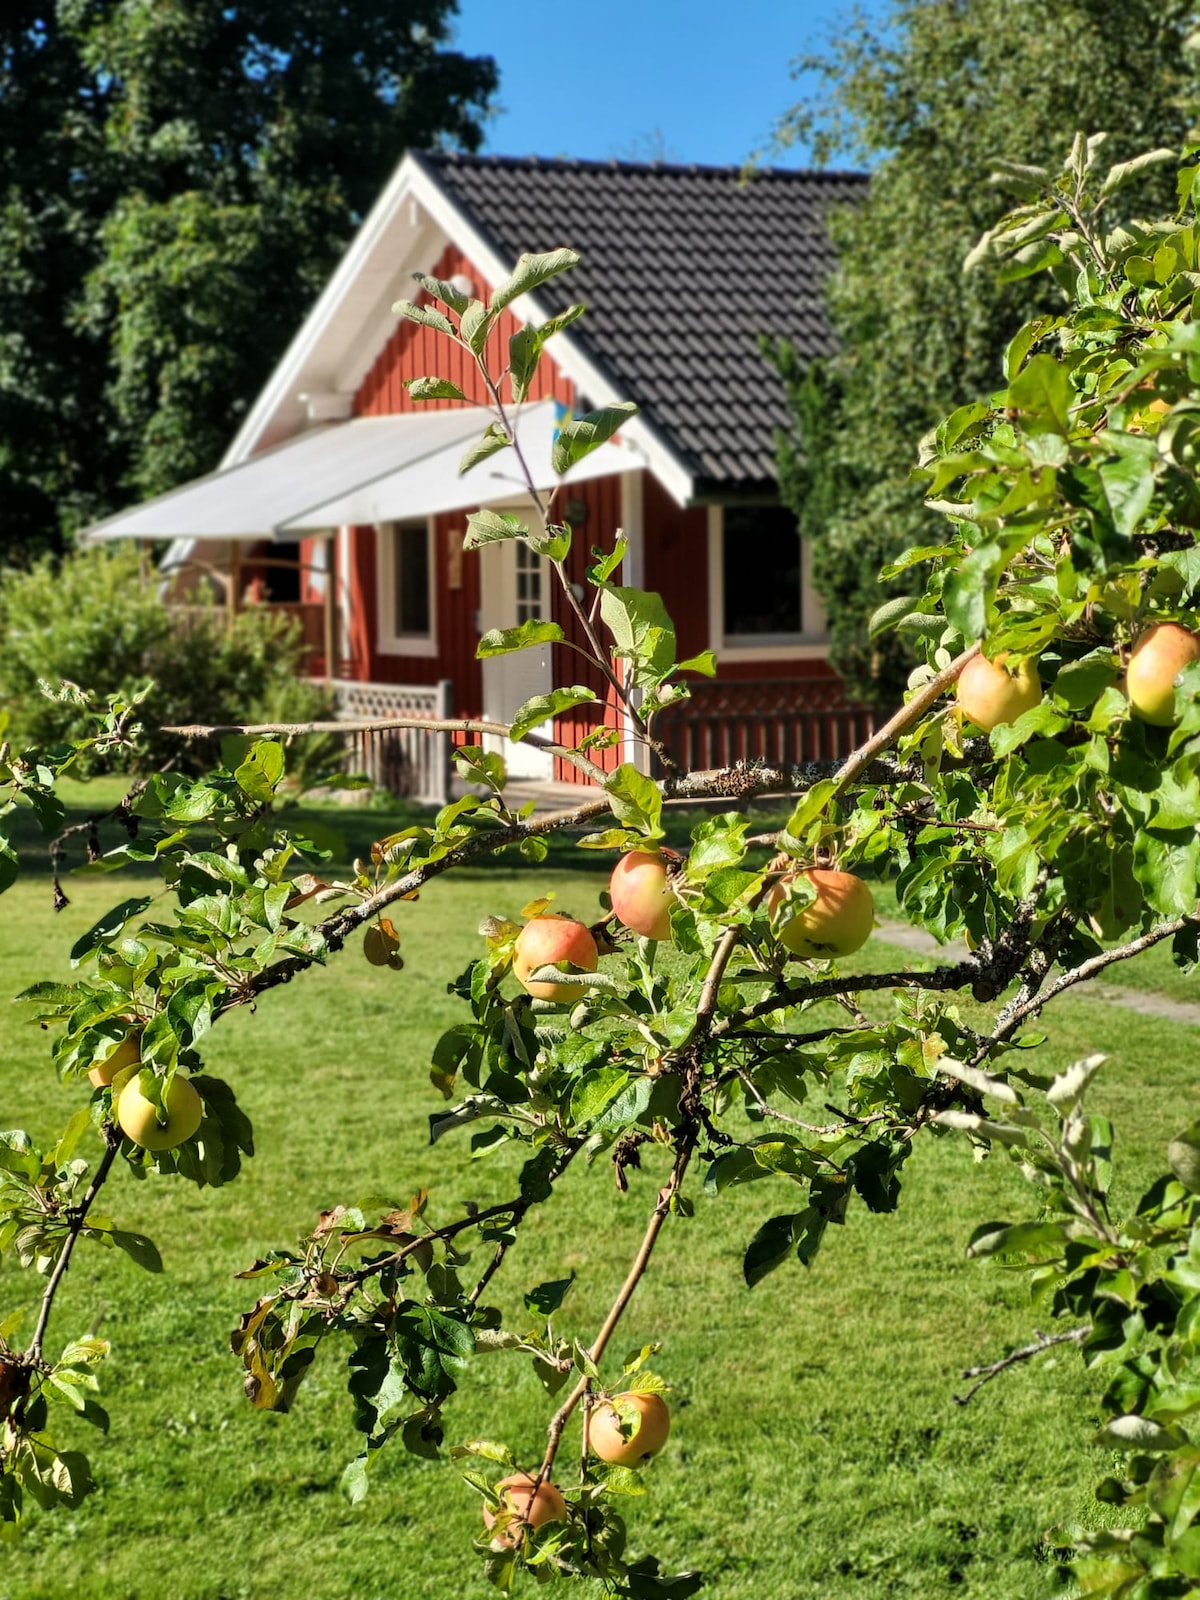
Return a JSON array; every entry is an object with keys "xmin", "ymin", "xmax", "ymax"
[{"xmin": 776, "ymin": 0, "xmax": 1200, "ymax": 701}]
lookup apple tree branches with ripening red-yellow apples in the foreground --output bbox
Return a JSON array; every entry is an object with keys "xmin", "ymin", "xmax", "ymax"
[{"xmin": 0, "ymin": 136, "xmax": 1200, "ymax": 1600}]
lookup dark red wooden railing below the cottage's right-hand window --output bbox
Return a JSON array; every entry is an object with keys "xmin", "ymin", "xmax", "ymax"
[{"xmin": 658, "ymin": 678, "xmax": 877, "ymax": 771}]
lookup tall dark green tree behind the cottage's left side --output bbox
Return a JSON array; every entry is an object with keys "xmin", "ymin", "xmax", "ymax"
[{"xmin": 0, "ymin": 0, "xmax": 498, "ymax": 560}]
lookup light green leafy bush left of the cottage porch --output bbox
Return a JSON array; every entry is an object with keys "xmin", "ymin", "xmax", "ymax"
[{"xmin": 0, "ymin": 547, "xmax": 328, "ymax": 771}]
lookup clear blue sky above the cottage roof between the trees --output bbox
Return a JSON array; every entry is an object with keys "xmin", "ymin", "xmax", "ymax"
[{"xmin": 456, "ymin": 0, "xmax": 882, "ymax": 165}]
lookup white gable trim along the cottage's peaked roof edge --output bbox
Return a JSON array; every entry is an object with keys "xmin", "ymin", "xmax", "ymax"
[{"xmin": 221, "ymin": 155, "xmax": 694, "ymax": 506}]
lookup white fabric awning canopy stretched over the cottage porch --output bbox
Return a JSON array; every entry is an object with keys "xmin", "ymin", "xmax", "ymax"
[{"xmin": 82, "ymin": 400, "xmax": 643, "ymax": 542}]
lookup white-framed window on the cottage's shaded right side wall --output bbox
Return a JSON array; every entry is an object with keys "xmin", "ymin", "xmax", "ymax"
[{"xmin": 709, "ymin": 506, "xmax": 826, "ymax": 661}]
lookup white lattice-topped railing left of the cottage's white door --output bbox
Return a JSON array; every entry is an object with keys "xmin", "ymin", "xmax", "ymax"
[{"xmin": 333, "ymin": 678, "xmax": 453, "ymax": 805}]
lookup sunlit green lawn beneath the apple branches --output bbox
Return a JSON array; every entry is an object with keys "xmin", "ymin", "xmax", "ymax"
[{"xmin": 0, "ymin": 786, "xmax": 1195, "ymax": 1600}]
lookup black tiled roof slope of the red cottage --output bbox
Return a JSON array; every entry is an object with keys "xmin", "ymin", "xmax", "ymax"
[{"xmin": 419, "ymin": 154, "xmax": 866, "ymax": 493}]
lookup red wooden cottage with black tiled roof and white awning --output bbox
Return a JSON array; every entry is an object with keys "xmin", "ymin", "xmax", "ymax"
[{"xmin": 88, "ymin": 154, "xmax": 867, "ymax": 792}]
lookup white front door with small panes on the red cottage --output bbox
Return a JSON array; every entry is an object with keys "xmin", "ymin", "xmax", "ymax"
[{"xmin": 480, "ymin": 506, "xmax": 554, "ymax": 778}]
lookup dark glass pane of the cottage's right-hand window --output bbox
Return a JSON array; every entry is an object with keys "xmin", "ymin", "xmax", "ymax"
[{"xmin": 722, "ymin": 506, "xmax": 802, "ymax": 638}]
